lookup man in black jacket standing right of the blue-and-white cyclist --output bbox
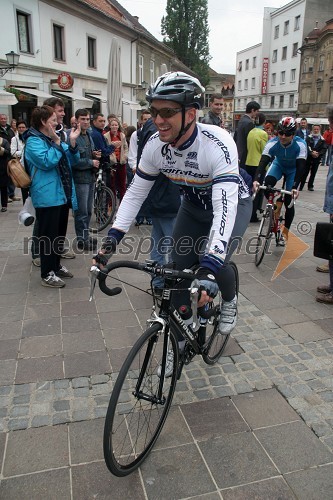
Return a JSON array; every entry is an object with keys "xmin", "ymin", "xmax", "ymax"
[{"xmin": 300, "ymin": 125, "xmax": 327, "ymax": 191}]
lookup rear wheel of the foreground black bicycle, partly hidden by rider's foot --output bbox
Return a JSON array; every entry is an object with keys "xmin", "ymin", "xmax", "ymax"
[{"xmin": 202, "ymin": 262, "xmax": 239, "ymax": 365}]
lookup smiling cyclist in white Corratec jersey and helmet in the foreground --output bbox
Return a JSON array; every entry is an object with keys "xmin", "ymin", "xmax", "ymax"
[{"xmin": 94, "ymin": 72, "xmax": 252, "ymax": 350}]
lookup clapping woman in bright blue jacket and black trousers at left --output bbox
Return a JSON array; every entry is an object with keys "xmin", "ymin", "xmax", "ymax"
[{"xmin": 24, "ymin": 106, "xmax": 80, "ymax": 288}]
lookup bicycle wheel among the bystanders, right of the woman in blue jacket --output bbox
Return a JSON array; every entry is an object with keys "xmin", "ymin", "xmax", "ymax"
[{"xmin": 90, "ymin": 184, "xmax": 116, "ymax": 232}]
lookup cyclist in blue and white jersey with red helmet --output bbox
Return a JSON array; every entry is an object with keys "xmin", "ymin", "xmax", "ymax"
[{"xmin": 253, "ymin": 116, "xmax": 307, "ymax": 239}]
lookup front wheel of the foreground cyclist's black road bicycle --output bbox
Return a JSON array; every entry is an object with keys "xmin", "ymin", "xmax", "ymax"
[{"xmin": 103, "ymin": 323, "xmax": 179, "ymax": 477}]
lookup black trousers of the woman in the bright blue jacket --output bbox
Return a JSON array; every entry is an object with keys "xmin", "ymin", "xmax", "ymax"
[{"xmin": 36, "ymin": 205, "xmax": 68, "ymax": 278}]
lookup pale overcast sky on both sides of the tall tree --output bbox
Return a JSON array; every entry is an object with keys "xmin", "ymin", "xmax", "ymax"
[{"xmin": 119, "ymin": 0, "xmax": 289, "ymax": 74}]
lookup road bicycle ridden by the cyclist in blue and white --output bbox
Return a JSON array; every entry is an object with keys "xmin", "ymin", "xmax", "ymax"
[{"xmin": 254, "ymin": 186, "xmax": 295, "ymax": 267}]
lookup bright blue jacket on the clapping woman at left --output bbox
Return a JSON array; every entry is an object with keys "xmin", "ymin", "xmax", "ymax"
[{"xmin": 24, "ymin": 128, "xmax": 80, "ymax": 210}]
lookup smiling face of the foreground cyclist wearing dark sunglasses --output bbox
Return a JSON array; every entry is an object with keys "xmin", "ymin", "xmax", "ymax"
[{"xmin": 151, "ymin": 99, "xmax": 196, "ymax": 143}]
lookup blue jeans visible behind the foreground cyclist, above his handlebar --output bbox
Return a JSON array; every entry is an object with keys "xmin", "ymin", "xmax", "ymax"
[{"xmin": 150, "ymin": 217, "xmax": 176, "ymax": 288}]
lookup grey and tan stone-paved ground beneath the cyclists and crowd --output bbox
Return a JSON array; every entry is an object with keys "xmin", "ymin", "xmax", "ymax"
[{"xmin": 0, "ymin": 169, "xmax": 333, "ymax": 499}]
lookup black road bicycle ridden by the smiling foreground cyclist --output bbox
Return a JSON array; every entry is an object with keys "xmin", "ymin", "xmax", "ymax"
[{"xmin": 91, "ymin": 261, "xmax": 239, "ymax": 477}]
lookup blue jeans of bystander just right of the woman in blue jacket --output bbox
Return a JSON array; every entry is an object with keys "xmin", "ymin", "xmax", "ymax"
[{"xmin": 74, "ymin": 183, "xmax": 94, "ymax": 241}]
